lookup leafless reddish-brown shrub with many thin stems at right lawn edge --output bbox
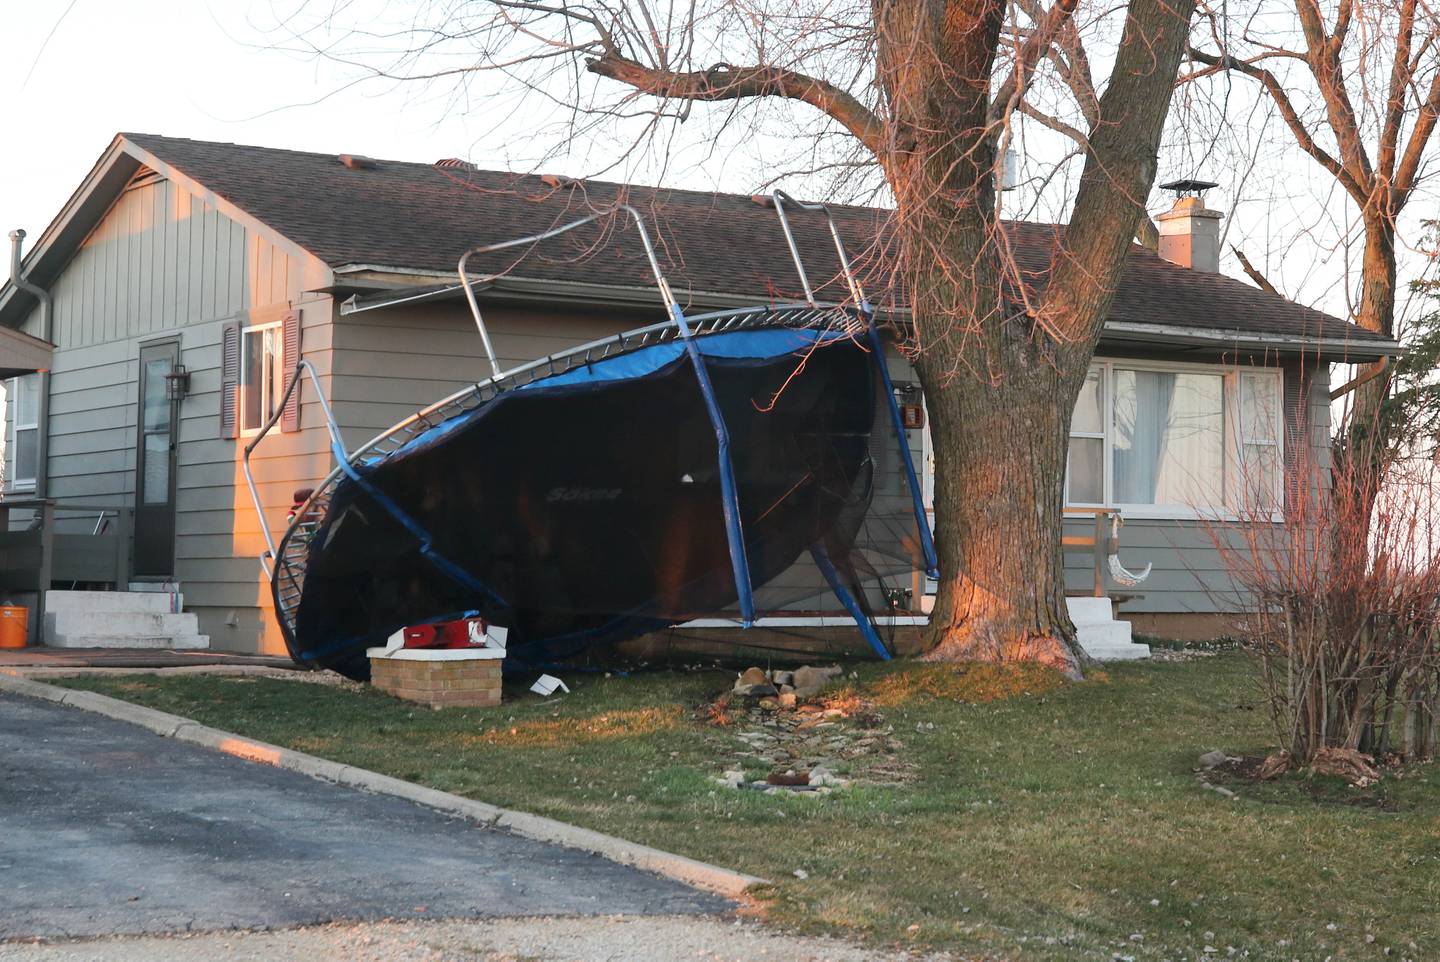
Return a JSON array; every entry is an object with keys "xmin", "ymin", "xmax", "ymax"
[{"xmin": 1215, "ymin": 423, "xmax": 1440, "ymax": 770}]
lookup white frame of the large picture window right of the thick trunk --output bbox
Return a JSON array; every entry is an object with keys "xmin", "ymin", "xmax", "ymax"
[{"xmin": 1066, "ymin": 357, "xmax": 1284, "ymax": 521}]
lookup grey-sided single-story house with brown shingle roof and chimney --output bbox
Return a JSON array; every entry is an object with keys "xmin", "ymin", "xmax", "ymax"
[{"xmin": 0, "ymin": 134, "xmax": 1398, "ymax": 652}]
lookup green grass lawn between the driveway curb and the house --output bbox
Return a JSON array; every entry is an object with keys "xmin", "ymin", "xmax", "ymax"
[{"xmin": 63, "ymin": 654, "xmax": 1440, "ymax": 961}]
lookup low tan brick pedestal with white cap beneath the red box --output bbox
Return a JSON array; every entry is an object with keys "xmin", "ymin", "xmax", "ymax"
[{"xmin": 366, "ymin": 648, "xmax": 505, "ymax": 709}]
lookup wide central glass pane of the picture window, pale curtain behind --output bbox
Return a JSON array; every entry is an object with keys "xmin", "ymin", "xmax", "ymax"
[{"xmin": 1115, "ymin": 369, "xmax": 1225, "ymax": 507}]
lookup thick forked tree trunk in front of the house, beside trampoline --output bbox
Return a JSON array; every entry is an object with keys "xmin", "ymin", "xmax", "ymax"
[{"xmin": 874, "ymin": 0, "xmax": 1194, "ymax": 675}]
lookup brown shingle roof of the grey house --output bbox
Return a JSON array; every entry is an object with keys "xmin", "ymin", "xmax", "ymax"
[{"xmin": 124, "ymin": 134, "xmax": 1384, "ymax": 343}]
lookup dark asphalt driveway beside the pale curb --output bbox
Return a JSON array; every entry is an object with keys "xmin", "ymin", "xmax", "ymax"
[{"xmin": 0, "ymin": 694, "xmax": 733, "ymax": 940}]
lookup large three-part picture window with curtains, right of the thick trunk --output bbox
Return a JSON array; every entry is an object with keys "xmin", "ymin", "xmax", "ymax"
[{"xmin": 1066, "ymin": 360, "xmax": 1282, "ymax": 517}]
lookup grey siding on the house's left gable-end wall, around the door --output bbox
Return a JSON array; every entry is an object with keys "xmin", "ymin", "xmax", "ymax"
[{"xmin": 6, "ymin": 170, "xmax": 333, "ymax": 651}]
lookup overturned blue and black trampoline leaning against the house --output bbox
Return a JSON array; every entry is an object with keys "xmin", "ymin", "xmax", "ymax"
[{"xmin": 245, "ymin": 193, "xmax": 935, "ymax": 678}]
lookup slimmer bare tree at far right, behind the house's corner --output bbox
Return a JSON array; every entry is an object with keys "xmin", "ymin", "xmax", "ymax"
[{"xmin": 1181, "ymin": 0, "xmax": 1440, "ymax": 478}]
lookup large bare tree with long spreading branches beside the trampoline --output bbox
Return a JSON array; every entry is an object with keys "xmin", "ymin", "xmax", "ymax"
[{"xmin": 275, "ymin": 0, "xmax": 1194, "ymax": 671}]
